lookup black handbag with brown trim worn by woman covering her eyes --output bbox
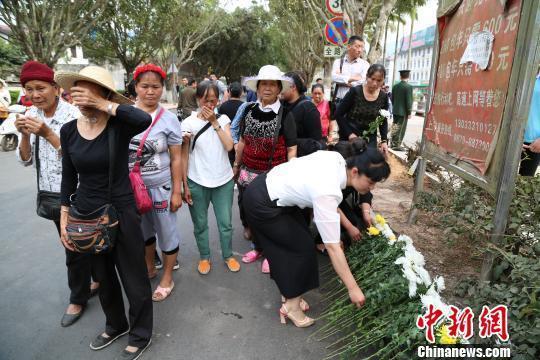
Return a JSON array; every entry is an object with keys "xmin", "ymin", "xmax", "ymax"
[{"xmin": 66, "ymin": 125, "xmax": 118, "ymax": 254}]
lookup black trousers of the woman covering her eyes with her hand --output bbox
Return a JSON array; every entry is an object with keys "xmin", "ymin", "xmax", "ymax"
[{"xmin": 92, "ymin": 206, "xmax": 153, "ymax": 348}]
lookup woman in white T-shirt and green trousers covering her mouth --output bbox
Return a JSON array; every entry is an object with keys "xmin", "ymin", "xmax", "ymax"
[{"xmin": 182, "ymin": 81, "xmax": 240, "ymax": 275}]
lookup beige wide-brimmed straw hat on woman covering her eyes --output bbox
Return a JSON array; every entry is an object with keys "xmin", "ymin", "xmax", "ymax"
[{"xmin": 54, "ymin": 66, "xmax": 133, "ymax": 104}]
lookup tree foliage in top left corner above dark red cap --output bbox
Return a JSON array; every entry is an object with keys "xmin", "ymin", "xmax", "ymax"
[{"xmin": 0, "ymin": 0, "xmax": 105, "ymax": 67}]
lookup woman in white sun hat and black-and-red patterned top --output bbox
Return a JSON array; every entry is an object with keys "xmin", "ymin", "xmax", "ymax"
[{"xmin": 233, "ymin": 65, "xmax": 296, "ymax": 273}]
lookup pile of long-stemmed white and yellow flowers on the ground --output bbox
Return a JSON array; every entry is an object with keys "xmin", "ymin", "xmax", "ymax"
[{"xmin": 313, "ymin": 214, "xmax": 463, "ymax": 359}]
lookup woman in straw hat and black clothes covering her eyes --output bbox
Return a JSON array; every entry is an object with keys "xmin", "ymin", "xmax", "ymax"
[{"xmin": 55, "ymin": 66, "xmax": 153, "ymax": 359}]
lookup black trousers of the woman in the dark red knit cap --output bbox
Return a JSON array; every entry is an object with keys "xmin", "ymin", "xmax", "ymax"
[{"xmin": 54, "ymin": 221, "xmax": 94, "ymax": 305}]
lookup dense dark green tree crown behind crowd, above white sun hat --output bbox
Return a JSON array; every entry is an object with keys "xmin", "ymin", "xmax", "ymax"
[{"xmin": 194, "ymin": 6, "xmax": 284, "ymax": 82}]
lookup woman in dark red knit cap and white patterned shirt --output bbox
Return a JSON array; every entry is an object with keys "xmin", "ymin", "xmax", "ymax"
[{"xmin": 15, "ymin": 61, "xmax": 99, "ymax": 327}]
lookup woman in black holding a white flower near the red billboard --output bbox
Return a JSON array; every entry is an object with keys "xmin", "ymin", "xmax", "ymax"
[{"xmin": 335, "ymin": 64, "xmax": 389, "ymax": 156}]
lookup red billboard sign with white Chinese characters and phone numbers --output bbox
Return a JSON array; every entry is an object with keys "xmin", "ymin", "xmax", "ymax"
[{"xmin": 424, "ymin": 0, "xmax": 521, "ymax": 174}]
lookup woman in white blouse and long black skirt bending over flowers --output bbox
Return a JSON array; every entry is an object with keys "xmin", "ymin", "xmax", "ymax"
[{"xmin": 244, "ymin": 141, "xmax": 390, "ymax": 327}]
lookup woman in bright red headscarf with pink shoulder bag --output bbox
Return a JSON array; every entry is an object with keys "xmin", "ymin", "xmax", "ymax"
[{"xmin": 129, "ymin": 64, "xmax": 182, "ymax": 301}]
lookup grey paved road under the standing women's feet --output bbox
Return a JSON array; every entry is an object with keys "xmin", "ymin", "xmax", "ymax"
[{"xmin": 0, "ymin": 152, "xmax": 326, "ymax": 360}]
